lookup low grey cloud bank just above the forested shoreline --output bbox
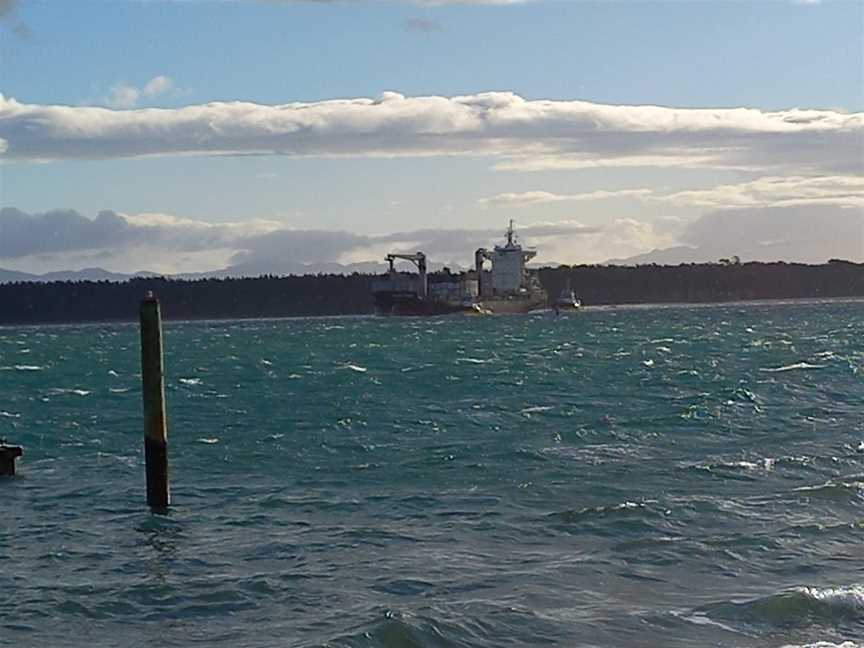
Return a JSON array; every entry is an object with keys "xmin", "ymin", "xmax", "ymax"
[{"xmin": 0, "ymin": 204, "xmax": 864, "ymax": 275}]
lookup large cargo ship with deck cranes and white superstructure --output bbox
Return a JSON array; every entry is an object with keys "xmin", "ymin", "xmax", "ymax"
[{"xmin": 372, "ymin": 220, "xmax": 549, "ymax": 315}]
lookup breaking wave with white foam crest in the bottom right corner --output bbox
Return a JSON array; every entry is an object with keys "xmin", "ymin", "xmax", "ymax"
[{"xmin": 696, "ymin": 585, "xmax": 864, "ymax": 628}]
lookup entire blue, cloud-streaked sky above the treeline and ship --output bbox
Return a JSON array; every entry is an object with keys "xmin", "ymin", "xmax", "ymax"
[{"xmin": 0, "ymin": 0, "xmax": 864, "ymax": 274}]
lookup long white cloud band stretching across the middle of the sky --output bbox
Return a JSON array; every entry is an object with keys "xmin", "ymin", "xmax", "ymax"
[{"xmin": 0, "ymin": 92, "xmax": 864, "ymax": 175}]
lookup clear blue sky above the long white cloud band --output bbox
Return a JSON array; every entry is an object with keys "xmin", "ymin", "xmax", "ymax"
[{"xmin": 3, "ymin": 0, "xmax": 864, "ymax": 110}]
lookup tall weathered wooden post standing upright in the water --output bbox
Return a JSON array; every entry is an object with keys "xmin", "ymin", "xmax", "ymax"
[{"xmin": 141, "ymin": 292, "xmax": 171, "ymax": 512}]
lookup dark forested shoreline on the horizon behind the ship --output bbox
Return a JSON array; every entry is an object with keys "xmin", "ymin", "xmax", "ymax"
[{"xmin": 0, "ymin": 260, "xmax": 864, "ymax": 325}]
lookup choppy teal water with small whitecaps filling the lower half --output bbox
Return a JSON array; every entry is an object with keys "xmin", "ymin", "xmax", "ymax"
[{"xmin": 0, "ymin": 302, "xmax": 864, "ymax": 647}]
